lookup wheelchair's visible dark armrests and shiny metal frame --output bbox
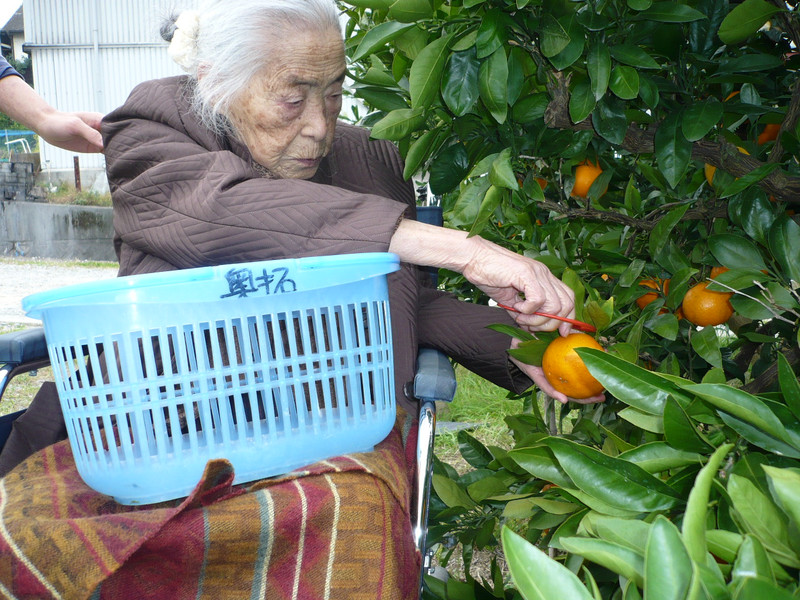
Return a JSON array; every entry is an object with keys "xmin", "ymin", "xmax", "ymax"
[{"xmin": 0, "ymin": 264, "xmax": 456, "ymax": 594}]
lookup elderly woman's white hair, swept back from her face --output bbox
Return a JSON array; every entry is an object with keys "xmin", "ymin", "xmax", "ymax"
[{"xmin": 161, "ymin": 0, "xmax": 341, "ymax": 132}]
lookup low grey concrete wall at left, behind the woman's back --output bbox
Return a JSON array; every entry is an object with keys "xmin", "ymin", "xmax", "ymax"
[{"xmin": 0, "ymin": 201, "xmax": 117, "ymax": 261}]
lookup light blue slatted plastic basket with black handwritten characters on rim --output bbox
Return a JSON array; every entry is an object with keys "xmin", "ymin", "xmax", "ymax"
[{"xmin": 22, "ymin": 253, "xmax": 398, "ymax": 504}]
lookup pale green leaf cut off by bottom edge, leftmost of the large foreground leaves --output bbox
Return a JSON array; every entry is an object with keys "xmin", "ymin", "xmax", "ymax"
[{"xmin": 500, "ymin": 525, "xmax": 594, "ymax": 600}]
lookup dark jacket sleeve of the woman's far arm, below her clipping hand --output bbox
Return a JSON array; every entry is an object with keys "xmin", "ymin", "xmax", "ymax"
[{"xmin": 417, "ymin": 288, "xmax": 533, "ymax": 393}]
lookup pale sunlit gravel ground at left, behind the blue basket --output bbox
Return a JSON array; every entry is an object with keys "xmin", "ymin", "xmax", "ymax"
[{"xmin": 0, "ymin": 258, "xmax": 117, "ymax": 332}]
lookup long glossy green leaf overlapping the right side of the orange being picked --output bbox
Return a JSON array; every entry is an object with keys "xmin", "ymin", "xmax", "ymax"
[{"xmin": 581, "ymin": 348, "xmax": 688, "ymax": 416}]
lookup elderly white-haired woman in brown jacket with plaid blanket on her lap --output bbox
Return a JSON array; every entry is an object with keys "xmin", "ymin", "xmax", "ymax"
[{"xmin": 0, "ymin": 0, "xmax": 596, "ymax": 599}]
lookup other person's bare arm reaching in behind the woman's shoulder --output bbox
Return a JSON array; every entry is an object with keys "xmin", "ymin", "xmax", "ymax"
[{"xmin": 0, "ymin": 61, "xmax": 103, "ymax": 152}]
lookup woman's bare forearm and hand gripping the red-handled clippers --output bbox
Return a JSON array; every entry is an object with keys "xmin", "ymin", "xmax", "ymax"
[{"xmin": 389, "ymin": 219, "xmax": 575, "ymax": 335}]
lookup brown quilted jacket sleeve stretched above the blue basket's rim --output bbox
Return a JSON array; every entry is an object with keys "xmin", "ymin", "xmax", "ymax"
[{"xmin": 103, "ymin": 80, "xmax": 406, "ymax": 268}]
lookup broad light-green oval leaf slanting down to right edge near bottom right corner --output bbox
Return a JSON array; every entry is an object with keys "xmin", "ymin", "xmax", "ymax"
[{"xmin": 727, "ymin": 474, "xmax": 800, "ymax": 568}]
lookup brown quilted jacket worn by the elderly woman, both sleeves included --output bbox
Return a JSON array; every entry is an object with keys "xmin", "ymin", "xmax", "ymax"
[{"xmin": 103, "ymin": 77, "xmax": 531, "ymax": 407}]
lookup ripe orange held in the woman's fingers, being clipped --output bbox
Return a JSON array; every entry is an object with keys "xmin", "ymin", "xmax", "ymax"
[{"xmin": 542, "ymin": 333, "xmax": 604, "ymax": 399}]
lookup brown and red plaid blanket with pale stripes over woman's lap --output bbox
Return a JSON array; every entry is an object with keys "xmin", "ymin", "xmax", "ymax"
[{"xmin": 0, "ymin": 417, "xmax": 419, "ymax": 600}]
